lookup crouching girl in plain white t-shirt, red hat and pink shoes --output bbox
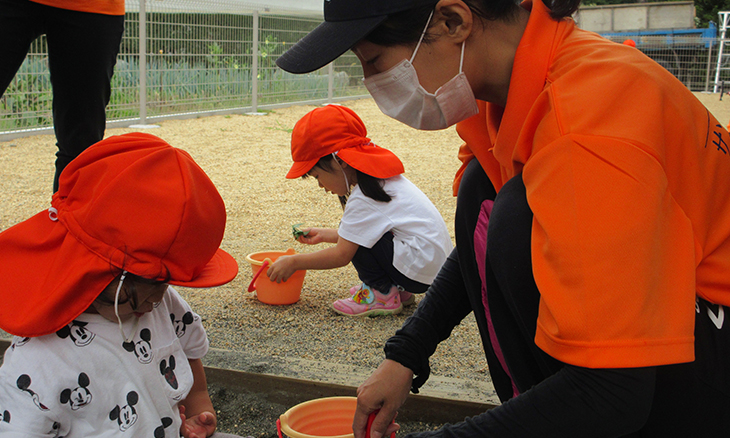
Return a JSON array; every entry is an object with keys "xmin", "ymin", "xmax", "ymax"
[{"xmin": 267, "ymin": 105, "xmax": 452, "ymax": 316}]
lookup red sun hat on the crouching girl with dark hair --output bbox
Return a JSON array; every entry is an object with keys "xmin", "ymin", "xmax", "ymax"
[{"xmin": 286, "ymin": 105, "xmax": 405, "ymax": 178}]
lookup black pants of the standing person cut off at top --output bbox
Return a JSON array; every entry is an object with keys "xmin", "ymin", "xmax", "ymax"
[{"xmin": 0, "ymin": 0, "xmax": 124, "ymax": 192}]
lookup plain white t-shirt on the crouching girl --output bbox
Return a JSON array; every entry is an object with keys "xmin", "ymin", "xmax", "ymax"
[{"xmin": 337, "ymin": 175, "xmax": 453, "ymax": 284}]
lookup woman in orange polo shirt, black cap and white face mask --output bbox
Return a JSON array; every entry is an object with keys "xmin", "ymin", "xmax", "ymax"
[{"xmin": 277, "ymin": 0, "xmax": 730, "ymax": 438}]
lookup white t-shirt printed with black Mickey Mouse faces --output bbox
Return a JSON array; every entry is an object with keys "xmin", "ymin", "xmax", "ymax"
[{"xmin": 0, "ymin": 288, "xmax": 208, "ymax": 438}]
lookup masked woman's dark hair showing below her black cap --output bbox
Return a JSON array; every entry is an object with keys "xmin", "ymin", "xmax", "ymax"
[{"xmin": 365, "ymin": 0, "xmax": 581, "ymax": 46}]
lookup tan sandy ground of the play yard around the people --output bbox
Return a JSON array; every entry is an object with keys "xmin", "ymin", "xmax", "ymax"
[{"xmin": 0, "ymin": 94, "xmax": 730, "ymax": 437}]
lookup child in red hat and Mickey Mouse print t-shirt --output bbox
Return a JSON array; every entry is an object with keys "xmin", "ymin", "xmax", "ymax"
[{"xmin": 0, "ymin": 133, "xmax": 238, "ymax": 438}]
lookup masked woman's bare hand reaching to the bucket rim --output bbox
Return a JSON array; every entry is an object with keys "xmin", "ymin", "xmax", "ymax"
[{"xmin": 352, "ymin": 359, "xmax": 413, "ymax": 438}]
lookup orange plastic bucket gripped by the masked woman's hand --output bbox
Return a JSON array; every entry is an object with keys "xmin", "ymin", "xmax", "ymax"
[{"xmin": 276, "ymin": 397, "xmax": 357, "ymax": 438}]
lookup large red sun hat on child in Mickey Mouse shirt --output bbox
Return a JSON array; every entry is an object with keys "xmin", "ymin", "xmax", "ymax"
[{"xmin": 0, "ymin": 133, "xmax": 238, "ymax": 336}]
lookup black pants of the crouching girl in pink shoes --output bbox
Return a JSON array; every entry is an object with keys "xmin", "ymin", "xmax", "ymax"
[{"xmin": 352, "ymin": 232, "xmax": 428, "ymax": 294}]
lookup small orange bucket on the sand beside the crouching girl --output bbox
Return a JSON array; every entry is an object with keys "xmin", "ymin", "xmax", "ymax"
[{"xmin": 246, "ymin": 248, "xmax": 307, "ymax": 305}]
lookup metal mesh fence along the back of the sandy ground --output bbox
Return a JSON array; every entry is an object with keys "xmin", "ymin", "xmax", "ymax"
[{"xmin": 0, "ymin": 0, "xmax": 730, "ymax": 140}]
